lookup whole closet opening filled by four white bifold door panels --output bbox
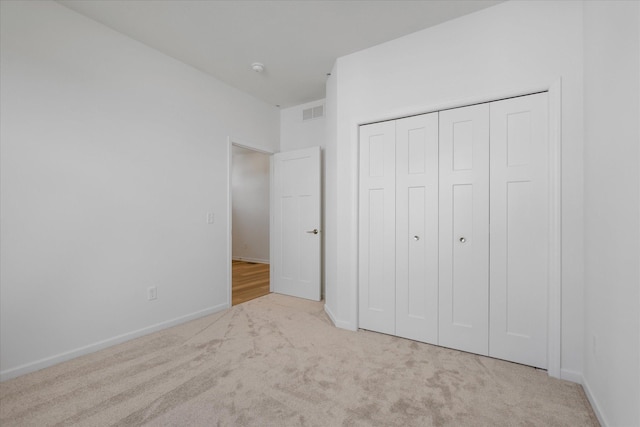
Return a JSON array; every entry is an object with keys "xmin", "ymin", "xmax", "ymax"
[{"xmin": 358, "ymin": 88, "xmax": 560, "ymax": 376}]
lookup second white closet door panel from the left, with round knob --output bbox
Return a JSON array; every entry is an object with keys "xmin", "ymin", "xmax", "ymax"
[{"xmin": 396, "ymin": 113, "xmax": 438, "ymax": 344}]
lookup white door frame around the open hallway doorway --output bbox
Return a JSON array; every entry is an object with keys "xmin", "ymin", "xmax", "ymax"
[{"xmin": 226, "ymin": 136, "xmax": 275, "ymax": 308}]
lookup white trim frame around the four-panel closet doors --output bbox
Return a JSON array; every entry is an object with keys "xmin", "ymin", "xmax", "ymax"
[{"xmin": 350, "ymin": 77, "xmax": 562, "ymax": 378}]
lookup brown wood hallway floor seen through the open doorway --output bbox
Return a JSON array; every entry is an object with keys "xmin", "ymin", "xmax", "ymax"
[{"xmin": 231, "ymin": 261, "xmax": 269, "ymax": 305}]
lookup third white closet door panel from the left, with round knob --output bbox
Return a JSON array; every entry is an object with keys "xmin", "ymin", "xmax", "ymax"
[{"xmin": 439, "ymin": 104, "xmax": 489, "ymax": 355}]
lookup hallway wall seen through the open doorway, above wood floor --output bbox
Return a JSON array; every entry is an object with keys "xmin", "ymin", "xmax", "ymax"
[{"xmin": 231, "ymin": 147, "xmax": 271, "ymax": 263}]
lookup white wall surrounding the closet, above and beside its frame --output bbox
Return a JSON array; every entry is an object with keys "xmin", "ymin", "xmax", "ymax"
[{"xmin": 326, "ymin": 1, "xmax": 584, "ymax": 381}]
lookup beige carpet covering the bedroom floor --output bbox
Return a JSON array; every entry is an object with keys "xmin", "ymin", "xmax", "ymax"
[{"xmin": 0, "ymin": 294, "xmax": 598, "ymax": 427}]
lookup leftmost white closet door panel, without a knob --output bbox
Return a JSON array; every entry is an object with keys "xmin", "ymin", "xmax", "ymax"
[{"xmin": 358, "ymin": 121, "xmax": 396, "ymax": 334}]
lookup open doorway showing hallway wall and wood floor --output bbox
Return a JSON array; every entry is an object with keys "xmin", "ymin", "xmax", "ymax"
[{"xmin": 230, "ymin": 143, "xmax": 271, "ymax": 305}]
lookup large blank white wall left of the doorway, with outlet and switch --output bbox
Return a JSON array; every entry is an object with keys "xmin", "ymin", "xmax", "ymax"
[{"xmin": 0, "ymin": 1, "xmax": 279, "ymax": 378}]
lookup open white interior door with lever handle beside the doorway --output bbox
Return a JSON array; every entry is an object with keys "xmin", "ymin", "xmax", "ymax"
[{"xmin": 271, "ymin": 147, "xmax": 321, "ymax": 301}]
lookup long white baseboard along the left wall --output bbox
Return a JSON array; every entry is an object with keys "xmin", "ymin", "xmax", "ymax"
[{"xmin": 0, "ymin": 303, "xmax": 229, "ymax": 382}]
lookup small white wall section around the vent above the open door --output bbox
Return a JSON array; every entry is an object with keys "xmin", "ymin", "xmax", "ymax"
[{"xmin": 280, "ymin": 99, "xmax": 326, "ymax": 151}]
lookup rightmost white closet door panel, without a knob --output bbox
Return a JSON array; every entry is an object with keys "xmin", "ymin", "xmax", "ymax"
[{"xmin": 489, "ymin": 93, "xmax": 549, "ymax": 368}]
